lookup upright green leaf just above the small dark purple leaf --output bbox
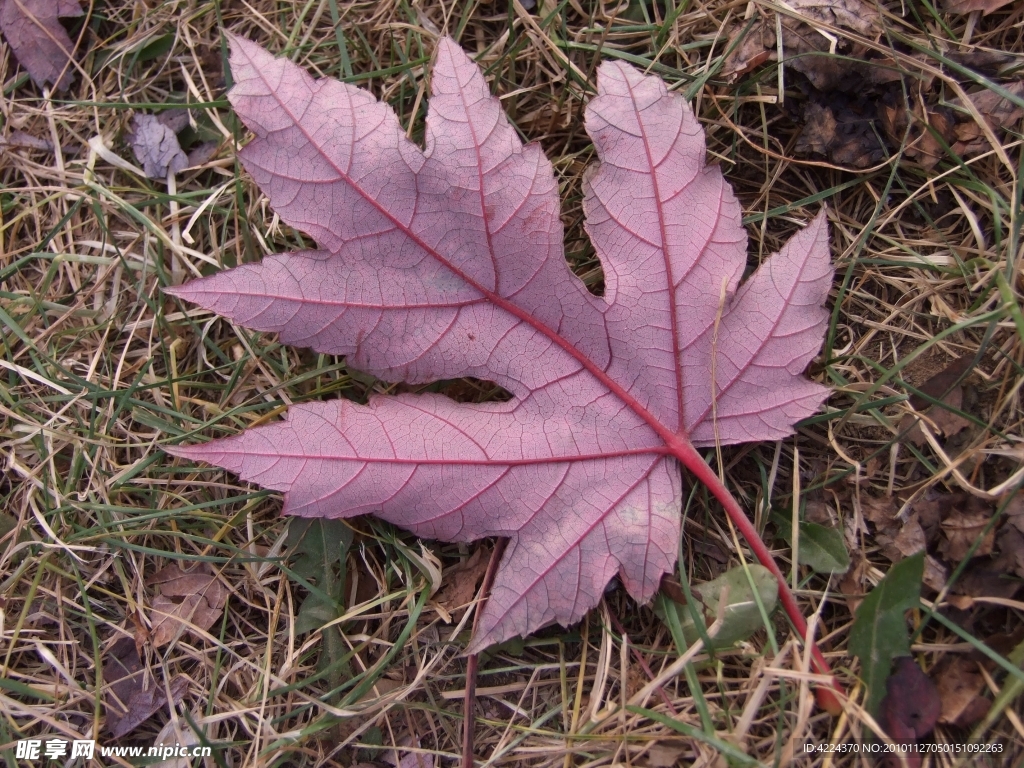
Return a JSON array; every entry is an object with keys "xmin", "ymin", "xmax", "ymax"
[{"xmin": 850, "ymin": 552, "xmax": 925, "ymax": 715}]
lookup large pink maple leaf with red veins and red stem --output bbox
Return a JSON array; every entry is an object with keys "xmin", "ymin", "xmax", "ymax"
[{"xmin": 168, "ymin": 38, "xmax": 833, "ymax": 669}]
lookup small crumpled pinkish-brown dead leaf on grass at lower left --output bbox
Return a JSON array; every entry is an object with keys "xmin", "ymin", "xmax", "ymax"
[{"xmin": 150, "ymin": 563, "xmax": 229, "ymax": 648}]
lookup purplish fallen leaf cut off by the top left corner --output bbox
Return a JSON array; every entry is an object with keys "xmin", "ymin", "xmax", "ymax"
[{"xmin": 0, "ymin": 0, "xmax": 82, "ymax": 91}]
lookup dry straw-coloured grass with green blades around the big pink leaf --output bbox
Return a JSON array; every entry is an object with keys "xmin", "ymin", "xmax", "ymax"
[{"xmin": 6, "ymin": 0, "xmax": 1024, "ymax": 767}]
